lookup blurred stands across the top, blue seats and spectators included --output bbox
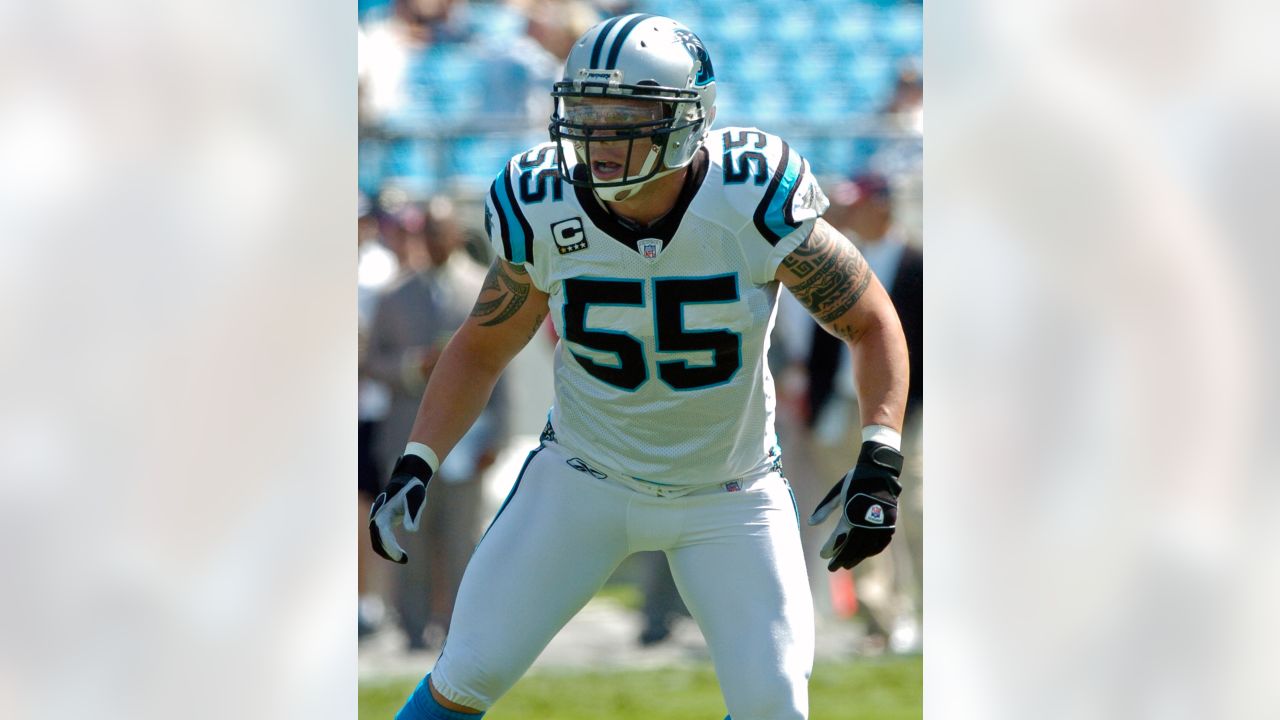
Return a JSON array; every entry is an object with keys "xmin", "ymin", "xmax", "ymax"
[{"xmin": 358, "ymin": 0, "xmax": 923, "ymax": 204}]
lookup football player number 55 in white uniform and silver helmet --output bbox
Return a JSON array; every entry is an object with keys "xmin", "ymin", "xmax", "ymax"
[{"xmin": 370, "ymin": 14, "xmax": 908, "ymax": 720}]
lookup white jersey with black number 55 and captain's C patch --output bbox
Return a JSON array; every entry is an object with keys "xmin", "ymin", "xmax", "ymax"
[{"xmin": 485, "ymin": 128, "xmax": 828, "ymax": 486}]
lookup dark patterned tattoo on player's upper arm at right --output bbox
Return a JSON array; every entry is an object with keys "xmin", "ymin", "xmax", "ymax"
[{"xmin": 782, "ymin": 223, "xmax": 872, "ymax": 325}]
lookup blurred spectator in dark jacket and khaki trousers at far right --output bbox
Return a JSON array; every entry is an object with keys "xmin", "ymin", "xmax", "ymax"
[{"xmin": 809, "ymin": 173, "xmax": 924, "ymax": 652}]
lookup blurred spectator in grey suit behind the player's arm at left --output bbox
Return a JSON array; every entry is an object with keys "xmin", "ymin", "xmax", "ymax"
[{"xmin": 367, "ymin": 197, "xmax": 509, "ymax": 650}]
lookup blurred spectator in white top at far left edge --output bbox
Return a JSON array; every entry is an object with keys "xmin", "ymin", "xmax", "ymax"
[{"xmin": 356, "ymin": 193, "xmax": 399, "ymax": 635}]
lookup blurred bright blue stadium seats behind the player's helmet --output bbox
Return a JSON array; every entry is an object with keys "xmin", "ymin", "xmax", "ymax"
[{"xmin": 358, "ymin": 0, "xmax": 923, "ymax": 193}]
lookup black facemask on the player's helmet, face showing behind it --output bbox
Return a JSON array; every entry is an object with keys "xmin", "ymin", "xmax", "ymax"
[{"xmin": 549, "ymin": 73, "xmax": 708, "ymax": 201}]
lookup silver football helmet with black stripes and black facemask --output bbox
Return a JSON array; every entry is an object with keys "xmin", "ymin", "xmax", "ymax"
[{"xmin": 549, "ymin": 14, "xmax": 716, "ymax": 201}]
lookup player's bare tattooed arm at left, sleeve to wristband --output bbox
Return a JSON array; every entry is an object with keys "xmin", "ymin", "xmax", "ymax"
[{"xmin": 410, "ymin": 258, "xmax": 547, "ymax": 460}]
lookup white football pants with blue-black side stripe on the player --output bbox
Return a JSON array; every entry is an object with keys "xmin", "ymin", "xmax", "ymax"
[{"xmin": 431, "ymin": 442, "xmax": 814, "ymax": 720}]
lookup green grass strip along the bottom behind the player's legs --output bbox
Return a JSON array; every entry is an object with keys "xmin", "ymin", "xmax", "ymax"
[{"xmin": 360, "ymin": 656, "xmax": 923, "ymax": 720}]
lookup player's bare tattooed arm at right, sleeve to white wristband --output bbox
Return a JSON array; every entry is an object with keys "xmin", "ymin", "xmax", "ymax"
[{"xmin": 777, "ymin": 218, "xmax": 908, "ymax": 430}]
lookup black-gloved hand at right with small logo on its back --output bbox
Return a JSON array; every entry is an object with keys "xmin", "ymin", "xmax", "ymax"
[{"xmin": 809, "ymin": 441, "xmax": 902, "ymax": 571}]
